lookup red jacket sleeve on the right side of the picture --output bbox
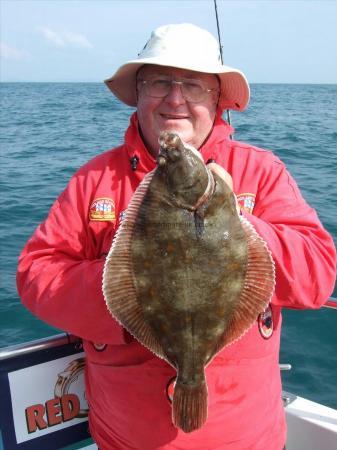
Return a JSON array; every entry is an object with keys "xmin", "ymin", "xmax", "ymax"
[{"xmin": 244, "ymin": 152, "xmax": 336, "ymax": 309}]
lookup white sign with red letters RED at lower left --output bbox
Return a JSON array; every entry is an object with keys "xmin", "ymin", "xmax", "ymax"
[{"xmin": 8, "ymin": 353, "xmax": 88, "ymax": 444}]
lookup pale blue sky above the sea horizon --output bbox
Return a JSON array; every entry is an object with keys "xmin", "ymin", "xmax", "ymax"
[{"xmin": 0, "ymin": 0, "xmax": 337, "ymax": 83}]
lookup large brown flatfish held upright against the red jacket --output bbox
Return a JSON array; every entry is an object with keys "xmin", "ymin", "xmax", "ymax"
[{"xmin": 103, "ymin": 132, "xmax": 275, "ymax": 433}]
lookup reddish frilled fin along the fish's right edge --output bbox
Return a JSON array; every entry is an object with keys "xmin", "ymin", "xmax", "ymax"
[{"xmin": 216, "ymin": 216, "xmax": 275, "ymax": 353}]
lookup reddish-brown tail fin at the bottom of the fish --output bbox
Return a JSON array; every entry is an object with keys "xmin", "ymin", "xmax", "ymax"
[{"xmin": 172, "ymin": 378, "xmax": 207, "ymax": 433}]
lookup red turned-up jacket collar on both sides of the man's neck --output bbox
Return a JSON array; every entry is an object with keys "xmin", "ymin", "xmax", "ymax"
[{"xmin": 125, "ymin": 112, "xmax": 234, "ymax": 174}]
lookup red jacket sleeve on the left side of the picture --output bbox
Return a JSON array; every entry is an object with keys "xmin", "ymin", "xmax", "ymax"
[{"xmin": 17, "ymin": 169, "xmax": 124, "ymax": 344}]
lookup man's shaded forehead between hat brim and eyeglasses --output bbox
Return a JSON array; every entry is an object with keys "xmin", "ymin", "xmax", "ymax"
[{"xmin": 137, "ymin": 64, "xmax": 219, "ymax": 87}]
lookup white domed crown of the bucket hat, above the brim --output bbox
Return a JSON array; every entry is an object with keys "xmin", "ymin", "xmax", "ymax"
[{"xmin": 138, "ymin": 23, "xmax": 221, "ymax": 67}]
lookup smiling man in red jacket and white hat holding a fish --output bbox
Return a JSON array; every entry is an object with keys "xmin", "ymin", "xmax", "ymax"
[{"xmin": 18, "ymin": 24, "xmax": 336, "ymax": 450}]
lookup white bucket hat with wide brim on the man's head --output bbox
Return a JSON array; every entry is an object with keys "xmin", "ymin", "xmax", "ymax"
[{"xmin": 105, "ymin": 23, "xmax": 249, "ymax": 111}]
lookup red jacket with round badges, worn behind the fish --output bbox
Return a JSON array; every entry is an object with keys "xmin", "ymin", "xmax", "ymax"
[{"xmin": 17, "ymin": 114, "xmax": 336, "ymax": 450}]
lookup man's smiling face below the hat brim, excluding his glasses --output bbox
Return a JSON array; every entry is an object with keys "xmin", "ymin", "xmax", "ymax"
[{"xmin": 137, "ymin": 65, "xmax": 219, "ymax": 156}]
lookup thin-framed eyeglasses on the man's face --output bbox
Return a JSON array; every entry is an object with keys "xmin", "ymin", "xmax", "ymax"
[{"xmin": 137, "ymin": 76, "xmax": 219, "ymax": 103}]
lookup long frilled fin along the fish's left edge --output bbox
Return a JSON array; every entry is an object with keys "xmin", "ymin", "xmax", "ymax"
[{"xmin": 102, "ymin": 171, "xmax": 167, "ymax": 360}]
